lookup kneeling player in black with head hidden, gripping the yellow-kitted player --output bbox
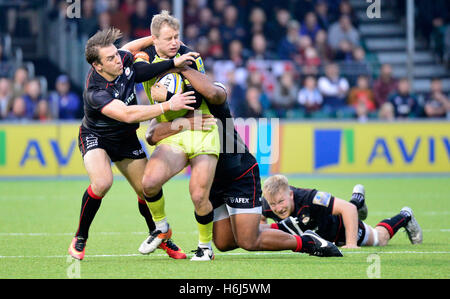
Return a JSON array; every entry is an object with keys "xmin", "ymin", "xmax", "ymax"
[{"xmin": 147, "ymin": 68, "xmax": 342, "ymax": 260}]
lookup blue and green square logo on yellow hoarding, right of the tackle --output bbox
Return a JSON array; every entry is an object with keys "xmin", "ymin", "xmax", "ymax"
[{"xmin": 314, "ymin": 129, "xmax": 355, "ymax": 170}]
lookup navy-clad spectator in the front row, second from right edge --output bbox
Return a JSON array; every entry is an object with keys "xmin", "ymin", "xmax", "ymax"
[{"xmin": 389, "ymin": 78, "xmax": 422, "ymax": 118}]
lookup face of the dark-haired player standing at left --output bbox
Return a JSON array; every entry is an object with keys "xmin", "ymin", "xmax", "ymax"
[{"xmin": 96, "ymin": 45, "xmax": 123, "ymax": 80}]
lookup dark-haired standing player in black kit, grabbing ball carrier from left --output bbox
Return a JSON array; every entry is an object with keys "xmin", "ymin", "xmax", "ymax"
[{"xmin": 69, "ymin": 28, "xmax": 197, "ymax": 260}]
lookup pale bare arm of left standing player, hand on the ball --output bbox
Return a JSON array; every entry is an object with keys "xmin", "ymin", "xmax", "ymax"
[{"xmin": 101, "ymin": 92, "xmax": 195, "ymax": 123}]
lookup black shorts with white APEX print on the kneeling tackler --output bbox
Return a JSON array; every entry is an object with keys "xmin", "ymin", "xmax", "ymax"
[{"xmin": 209, "ymin": 164, "xmax": 262, "ymax": 221}]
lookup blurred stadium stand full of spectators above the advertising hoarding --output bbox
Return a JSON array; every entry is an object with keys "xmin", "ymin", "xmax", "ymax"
[{"xmin": 0, "ymin": 0, "xmax": 450, "ymax": 121}]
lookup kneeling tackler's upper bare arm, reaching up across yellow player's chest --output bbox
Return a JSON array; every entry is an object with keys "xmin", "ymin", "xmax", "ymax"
[{"xmin": 181, "ymin": 67, "xmax": 227, "ymax": 105}]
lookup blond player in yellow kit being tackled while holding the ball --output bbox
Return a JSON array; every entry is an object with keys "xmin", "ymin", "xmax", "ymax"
[{"xmin": 126, "ymin": 11, "xmax": 223, "ymax": 260}]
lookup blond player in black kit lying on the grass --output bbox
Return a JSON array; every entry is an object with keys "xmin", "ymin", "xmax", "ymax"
[{"xmin": 262, "ymin": 175, "xmax": 422, "ymax": 248}]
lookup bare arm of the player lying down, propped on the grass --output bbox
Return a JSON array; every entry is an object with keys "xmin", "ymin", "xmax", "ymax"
[{"xmin": 332, "ymin": 197, "xmax": 358, "ymax": 248}]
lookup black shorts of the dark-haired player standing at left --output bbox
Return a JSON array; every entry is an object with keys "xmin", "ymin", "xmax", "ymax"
[{"xmin": 78, "ymin": 126, "xmax": 147, "ymax": 162}]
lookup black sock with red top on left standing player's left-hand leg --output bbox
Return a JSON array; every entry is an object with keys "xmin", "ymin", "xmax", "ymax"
[{"xmin": 75, "ymin": 186, "xmax": 102, "ymax": 240}]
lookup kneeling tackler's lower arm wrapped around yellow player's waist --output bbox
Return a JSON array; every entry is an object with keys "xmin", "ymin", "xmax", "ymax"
[{"xmin": 145, "ymin": 112, "xmax": 216, "ymax": 145}]
